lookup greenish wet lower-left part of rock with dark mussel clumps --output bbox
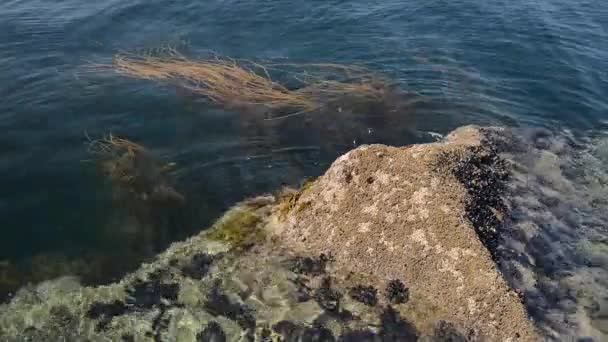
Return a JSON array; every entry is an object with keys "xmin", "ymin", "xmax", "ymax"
[{"xmin": 0, "ymin": 197, "xmax": 426, "ymax": 342}]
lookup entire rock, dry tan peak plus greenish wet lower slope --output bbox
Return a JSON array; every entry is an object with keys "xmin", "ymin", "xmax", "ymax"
[{"xmin": 0, "ymin": 127, "xmax": 539, "ymax": 341}]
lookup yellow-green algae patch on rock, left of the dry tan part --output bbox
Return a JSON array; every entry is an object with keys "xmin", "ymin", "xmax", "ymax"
[{"xmin": 207, "ymin": 207, "xmax": 266, "ymax": 250}]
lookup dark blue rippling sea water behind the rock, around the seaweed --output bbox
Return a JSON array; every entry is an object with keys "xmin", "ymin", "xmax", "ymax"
[{"xmin": 0, "ymin": 0, "xmax": 608, "ymax": 336}]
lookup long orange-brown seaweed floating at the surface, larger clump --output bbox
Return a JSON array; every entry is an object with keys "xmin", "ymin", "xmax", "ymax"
[{"xmin": 100, "ymin": 49, "xmax": 387, "ymax": 118}]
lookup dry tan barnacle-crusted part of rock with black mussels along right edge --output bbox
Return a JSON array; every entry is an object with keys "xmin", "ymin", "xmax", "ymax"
[{"xmin": 275, "ymin": 127, "xmax": 539, "ymax": 341}]
